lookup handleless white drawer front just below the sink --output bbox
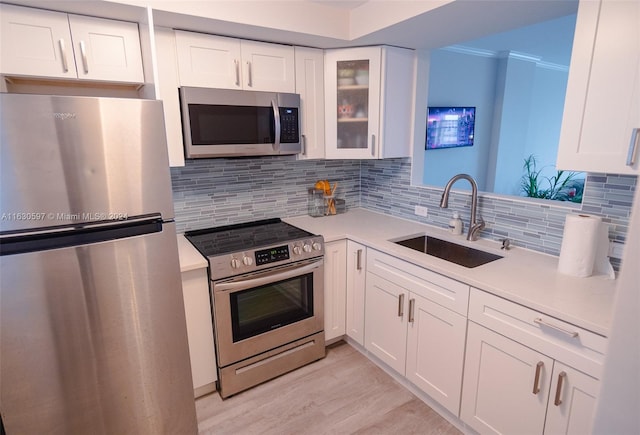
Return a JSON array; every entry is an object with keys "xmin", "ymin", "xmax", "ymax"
[{"xmin": 367, "ymin": 250, "xmax": 469, "ymax": 316}]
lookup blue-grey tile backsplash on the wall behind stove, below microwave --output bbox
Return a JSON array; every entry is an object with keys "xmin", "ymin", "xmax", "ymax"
[{"xmin": 171, "ymin": 156, "xmax": 360, "ymax": 232}]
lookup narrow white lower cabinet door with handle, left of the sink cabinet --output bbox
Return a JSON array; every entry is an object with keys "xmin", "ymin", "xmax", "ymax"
[{"xmin": 347, "ymin": 240, "xmax": 367, "ymax": 346}]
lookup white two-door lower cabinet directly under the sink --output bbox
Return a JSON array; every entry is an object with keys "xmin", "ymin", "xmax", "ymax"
[{"xmin": 365, "ymin": 249, "xmax": 469, "ymax": 416}]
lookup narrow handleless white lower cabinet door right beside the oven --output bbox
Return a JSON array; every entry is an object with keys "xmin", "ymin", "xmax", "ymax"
[{"xmin": 324, "ymin": 240, "xmax": 347, "ymax": 342}]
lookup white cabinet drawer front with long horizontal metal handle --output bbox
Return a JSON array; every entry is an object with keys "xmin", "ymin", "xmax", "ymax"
[{"xmin": 469, "ymin": 288, "xmax": 607, "ymax": 379}]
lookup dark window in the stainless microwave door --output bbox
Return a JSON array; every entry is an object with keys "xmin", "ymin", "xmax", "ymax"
[{"xmin": 189, "ymin": 104, "xmax": 276, "ymax": 145}]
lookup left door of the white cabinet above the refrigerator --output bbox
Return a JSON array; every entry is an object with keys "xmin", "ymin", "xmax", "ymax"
[{"xmin": 0, "ymin": 4, "xmax": 77, "ymax": 78}]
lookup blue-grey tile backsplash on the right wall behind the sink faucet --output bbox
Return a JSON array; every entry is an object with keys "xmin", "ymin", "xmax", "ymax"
[{"xmin": 360, "ymin": 159, "xmax": 637, "ymax": 269}]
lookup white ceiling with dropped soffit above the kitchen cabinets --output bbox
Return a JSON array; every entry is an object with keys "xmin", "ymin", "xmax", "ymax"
[{"xmin": 8, "ymin": 0, "xmax": 578, "ymax": 49}]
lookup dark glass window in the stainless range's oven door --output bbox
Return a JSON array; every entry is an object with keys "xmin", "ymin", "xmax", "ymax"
[{"xmin": 230, "ymin": 273, "xmax": 313, "ymax": 343}]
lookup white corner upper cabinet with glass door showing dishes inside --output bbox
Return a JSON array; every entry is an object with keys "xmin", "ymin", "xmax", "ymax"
[{"xmin": 325, "ymin": 46, "xmax": 414, "ymax": 159}]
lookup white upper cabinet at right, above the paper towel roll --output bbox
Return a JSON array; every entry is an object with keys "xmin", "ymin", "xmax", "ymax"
[{"xmin": 557, "ymin": 0, "xmax": 640, "ymax": 174}]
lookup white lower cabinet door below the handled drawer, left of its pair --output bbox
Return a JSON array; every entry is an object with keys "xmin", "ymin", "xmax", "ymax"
[{"xmin": 460, "ymin": 322, "xmax": 553, "ymax": 435}]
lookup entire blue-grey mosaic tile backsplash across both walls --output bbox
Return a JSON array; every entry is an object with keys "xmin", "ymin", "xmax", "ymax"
[{"xmin": 171, "ymin": 156, "xmax": 637, "ymax": 268}]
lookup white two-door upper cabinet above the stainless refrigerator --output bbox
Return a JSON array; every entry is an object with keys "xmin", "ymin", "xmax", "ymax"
[{"xmin": 0, "ymin": 4, "xmax": 144, "ymax": 83}]
